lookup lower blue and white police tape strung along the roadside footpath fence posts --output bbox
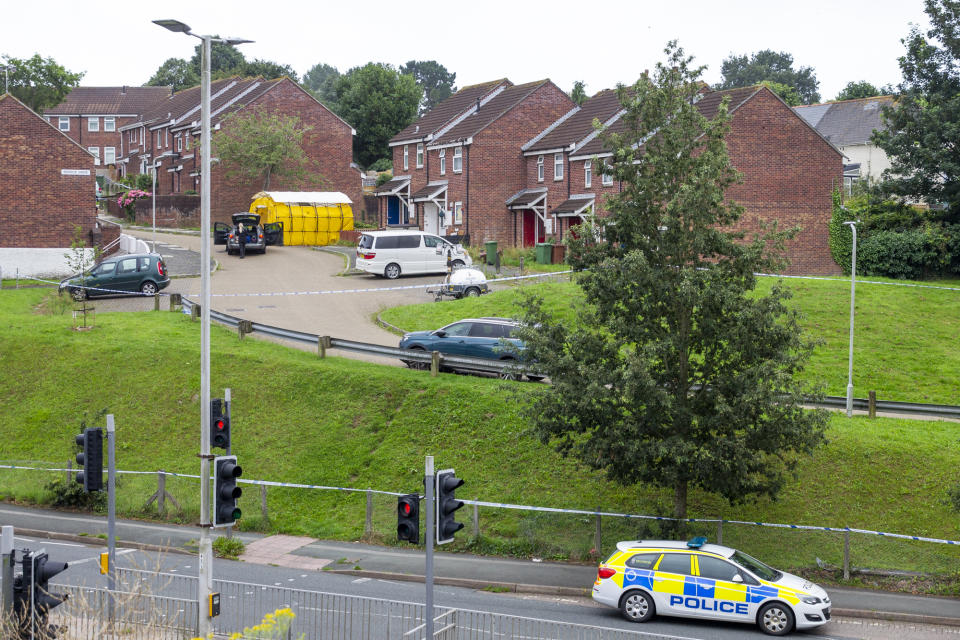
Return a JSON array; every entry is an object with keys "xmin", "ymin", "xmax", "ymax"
[{"xmin": 0, "ymin": 464, "xmax": 960, "ymax": 545}]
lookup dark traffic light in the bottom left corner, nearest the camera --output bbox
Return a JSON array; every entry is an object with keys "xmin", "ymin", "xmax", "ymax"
[{"xmin": 13, "ymin": 550, "xmax": 67, "ymax": 638}]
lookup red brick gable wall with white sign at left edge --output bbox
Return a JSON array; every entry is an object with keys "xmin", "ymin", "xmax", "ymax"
[{"xmin": 0, "ymin": 96, "xmax": 97, "ymax": 248}]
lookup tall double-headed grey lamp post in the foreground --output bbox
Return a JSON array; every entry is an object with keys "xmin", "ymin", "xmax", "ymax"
[{"xmin": 153, "ymin": 20, "xmax": 253, "ymax": 638}]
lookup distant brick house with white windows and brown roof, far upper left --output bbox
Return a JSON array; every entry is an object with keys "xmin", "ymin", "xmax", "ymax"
[{"xmin": 43, "ymin": 86, "xmax": 170, "ymax": 178}]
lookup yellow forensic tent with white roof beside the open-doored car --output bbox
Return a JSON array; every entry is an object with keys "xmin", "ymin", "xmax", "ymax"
[{"xmin": 250, "ymin": 191, "xmax": 353, "ymax": 246}]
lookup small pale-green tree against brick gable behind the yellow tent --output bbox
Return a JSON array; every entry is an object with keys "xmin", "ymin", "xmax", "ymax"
[{"xmin": 213, "ymin": 109, "xmax": 310, "ymax": 191}]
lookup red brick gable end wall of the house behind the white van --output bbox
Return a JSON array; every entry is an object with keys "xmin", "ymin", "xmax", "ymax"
[{"xmin": 462, "ymin": 82, "xmax": 574, "ymax": 246}]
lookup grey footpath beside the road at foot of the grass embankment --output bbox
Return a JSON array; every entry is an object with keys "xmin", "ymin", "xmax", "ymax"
[{"xmin": 0, "ymin": 504, "xmax": 960, "ymax": 627}]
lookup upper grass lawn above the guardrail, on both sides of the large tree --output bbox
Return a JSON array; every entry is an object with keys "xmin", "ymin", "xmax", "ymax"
[{"xmin": 381, "ymin": 278, "xmax": 960, "ymax": 404}]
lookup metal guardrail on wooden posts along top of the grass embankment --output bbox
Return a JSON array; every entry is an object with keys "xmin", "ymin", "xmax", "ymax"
[{"xmin": 183, "ymin": 298, "xmax": 960, "ymax": 419}]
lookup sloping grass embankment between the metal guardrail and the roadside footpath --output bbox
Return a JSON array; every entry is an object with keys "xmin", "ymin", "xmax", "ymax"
[{"xmin": 0, "ymin": 290, "xmax": 960, "ymax": 592}]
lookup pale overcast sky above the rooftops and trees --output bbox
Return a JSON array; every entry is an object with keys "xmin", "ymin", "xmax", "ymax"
[{"xmin": 0, "ymin": 0, "xmax": 928, "ymax": 100}]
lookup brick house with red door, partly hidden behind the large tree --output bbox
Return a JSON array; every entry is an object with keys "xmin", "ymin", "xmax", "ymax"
[{"xmin": 520, "ymin": 87, "xmax": 843, "ymax": 274}]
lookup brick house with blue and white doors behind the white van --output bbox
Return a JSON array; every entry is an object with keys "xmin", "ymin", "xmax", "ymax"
[{"xmin": 377, "ymin": 79, "xmax": 573, "ymax": 246}]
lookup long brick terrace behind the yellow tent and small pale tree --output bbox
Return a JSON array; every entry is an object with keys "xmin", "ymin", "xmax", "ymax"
[{"xmin": 119, "ymin": 77, "xmax": 363, "ymax": 224}]
